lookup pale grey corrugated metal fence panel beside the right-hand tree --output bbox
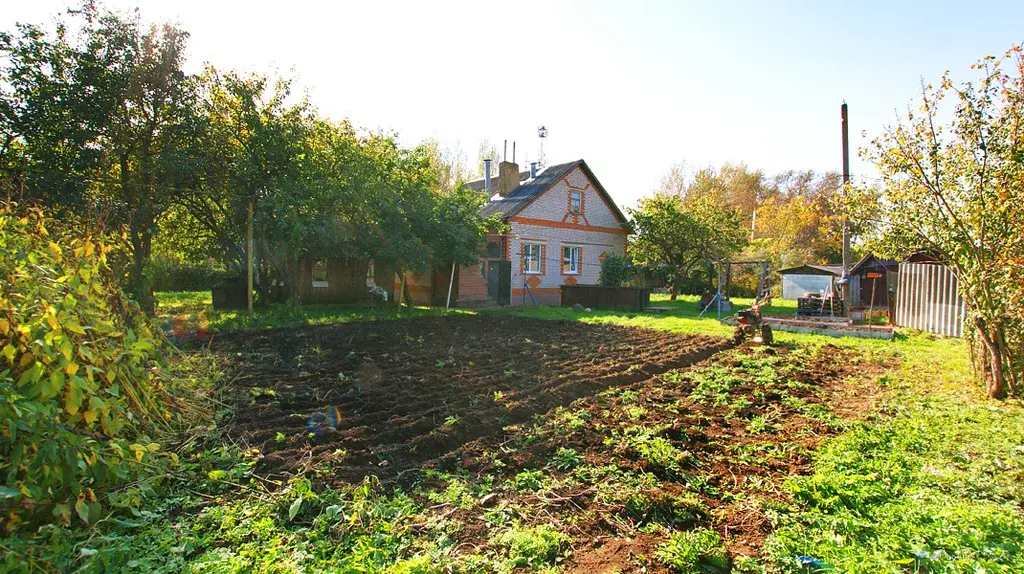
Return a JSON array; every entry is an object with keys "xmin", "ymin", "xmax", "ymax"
[{"xmin": 896, "ymin": 263, "xmax": 967, "ymax": 337}]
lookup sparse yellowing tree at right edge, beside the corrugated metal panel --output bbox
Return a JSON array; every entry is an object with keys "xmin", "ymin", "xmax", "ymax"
[{"xmin": 866, "ymin": 45, "xmax": 1024, "ymax": 398}]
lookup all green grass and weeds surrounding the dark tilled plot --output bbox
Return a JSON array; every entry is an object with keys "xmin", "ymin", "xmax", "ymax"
[{"xmin": 0, "ymin": 294, "xmax": 1024, "ymax": 573}]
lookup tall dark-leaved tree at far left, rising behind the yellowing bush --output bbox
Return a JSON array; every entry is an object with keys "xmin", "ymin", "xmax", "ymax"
[{"xmin": 0, "ymin": 2, "xmax": 193, "ymax": 311}]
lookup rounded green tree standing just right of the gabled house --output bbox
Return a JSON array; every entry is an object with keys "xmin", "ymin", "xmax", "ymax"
[{"xmin": 630, "ymin": 193, "xmax": 746, "ymax": 299}]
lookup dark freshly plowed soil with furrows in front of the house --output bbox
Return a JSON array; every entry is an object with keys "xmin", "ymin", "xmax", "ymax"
[{"xmin": 212, "ymin": 316, "xmax": 729, "ymax": 483}]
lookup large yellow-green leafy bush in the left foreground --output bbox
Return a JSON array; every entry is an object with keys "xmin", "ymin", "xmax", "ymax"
[{"xmin": 0, "ymin": 205, "xmax": 180, "ymax": 530}]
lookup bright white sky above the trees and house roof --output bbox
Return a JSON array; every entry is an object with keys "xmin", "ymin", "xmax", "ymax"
[{"xmin": 6, "ymin": 0, "xmax": 1024, "ymax": 207}]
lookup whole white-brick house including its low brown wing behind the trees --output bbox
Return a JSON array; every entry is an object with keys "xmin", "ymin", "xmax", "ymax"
[{"xmin": 284, "ymin": 160, "xmax": 628, "ymax": 307}]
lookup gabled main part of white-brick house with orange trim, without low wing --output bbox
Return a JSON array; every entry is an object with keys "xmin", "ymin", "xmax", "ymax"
[{"xmin": 456, "ymin": 160, "xmax": 629, "ymax": 307}]
